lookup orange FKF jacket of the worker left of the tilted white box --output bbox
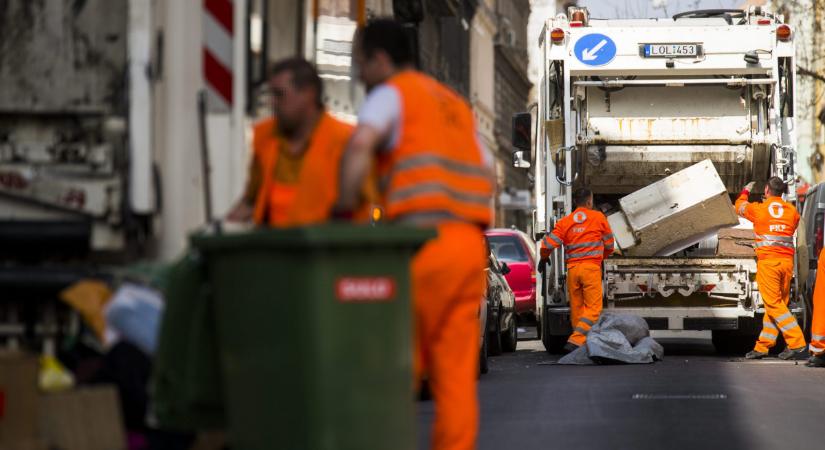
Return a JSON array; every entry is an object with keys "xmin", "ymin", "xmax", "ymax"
[{"xmin": 541, "ymin": 208, "xmax": 613, "ymax": 267}]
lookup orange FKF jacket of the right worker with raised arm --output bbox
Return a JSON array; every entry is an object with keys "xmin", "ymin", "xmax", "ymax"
[{"xmin": 734, "ymin": 191, "xmax": 799, "ymax": 259}]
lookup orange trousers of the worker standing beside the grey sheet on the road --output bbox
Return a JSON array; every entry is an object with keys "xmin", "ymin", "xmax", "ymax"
[{"xmin": 567, "ymin": 261, "xmax": 602, "ymax": 346}]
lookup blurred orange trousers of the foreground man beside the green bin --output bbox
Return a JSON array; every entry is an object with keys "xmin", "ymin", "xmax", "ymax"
[{"xmin": 412, "ymin": 223, "xmax": 487, "ymax": 450}]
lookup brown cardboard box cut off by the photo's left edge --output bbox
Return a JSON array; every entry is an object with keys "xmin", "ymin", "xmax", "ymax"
[{"xmin": 0, "ymin": 352, "xmax": 40, "ymax": 442}]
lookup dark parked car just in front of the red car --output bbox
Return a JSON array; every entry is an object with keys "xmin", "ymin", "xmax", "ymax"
[{"xmin": 482, "ymin": 252, "xmax": 518, "ymax": 356}]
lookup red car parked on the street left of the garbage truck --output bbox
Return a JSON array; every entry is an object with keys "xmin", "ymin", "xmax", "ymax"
[{"xmin": 485, "ymin": 228, "xmax": 536, "ymax": 318}]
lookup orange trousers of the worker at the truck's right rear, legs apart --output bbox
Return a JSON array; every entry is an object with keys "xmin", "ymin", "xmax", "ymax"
[{"xmin": 753, "ymin": 258, "xmax": 805, "ymax": 353}]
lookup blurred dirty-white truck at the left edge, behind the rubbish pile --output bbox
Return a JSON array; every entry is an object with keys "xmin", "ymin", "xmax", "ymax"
[{"xmin": 0, "ymin": 0, "xmax": 247, "ymax": 346}]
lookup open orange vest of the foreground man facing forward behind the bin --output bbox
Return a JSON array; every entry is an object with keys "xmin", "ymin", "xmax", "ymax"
[{"xmin": 253, "ymin": 112, "xmax": 353, "ymax": 227}]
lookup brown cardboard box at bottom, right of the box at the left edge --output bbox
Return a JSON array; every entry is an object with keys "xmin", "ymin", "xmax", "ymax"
[{"xmin": 39, "ymin": 386, "xmax": 126, "ymax": 450}]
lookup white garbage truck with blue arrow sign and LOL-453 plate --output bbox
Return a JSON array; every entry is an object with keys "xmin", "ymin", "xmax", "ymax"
[{"xmin": 513, "ymin": 7, "xmax": 810, "ymax": 351}]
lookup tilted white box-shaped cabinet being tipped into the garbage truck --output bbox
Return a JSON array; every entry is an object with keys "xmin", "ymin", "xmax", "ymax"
[{"xmin": 607, "ymin": 159, "xmax": 739, "ymax": 256}]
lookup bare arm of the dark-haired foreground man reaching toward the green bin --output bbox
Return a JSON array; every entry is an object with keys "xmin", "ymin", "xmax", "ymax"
[{"xmin": 335, "ymin": 124, "xmax": 386, "ymax": 213}]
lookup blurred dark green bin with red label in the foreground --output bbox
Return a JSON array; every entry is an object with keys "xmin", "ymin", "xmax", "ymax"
[{"xmin": 192, "ymin": 225, "xmax": 432, "ymax": 450}]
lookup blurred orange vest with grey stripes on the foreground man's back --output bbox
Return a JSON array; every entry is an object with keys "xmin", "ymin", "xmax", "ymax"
[{"xmin": 378, "ymin": 71, "xmax": 493, "ymax": 227}]
